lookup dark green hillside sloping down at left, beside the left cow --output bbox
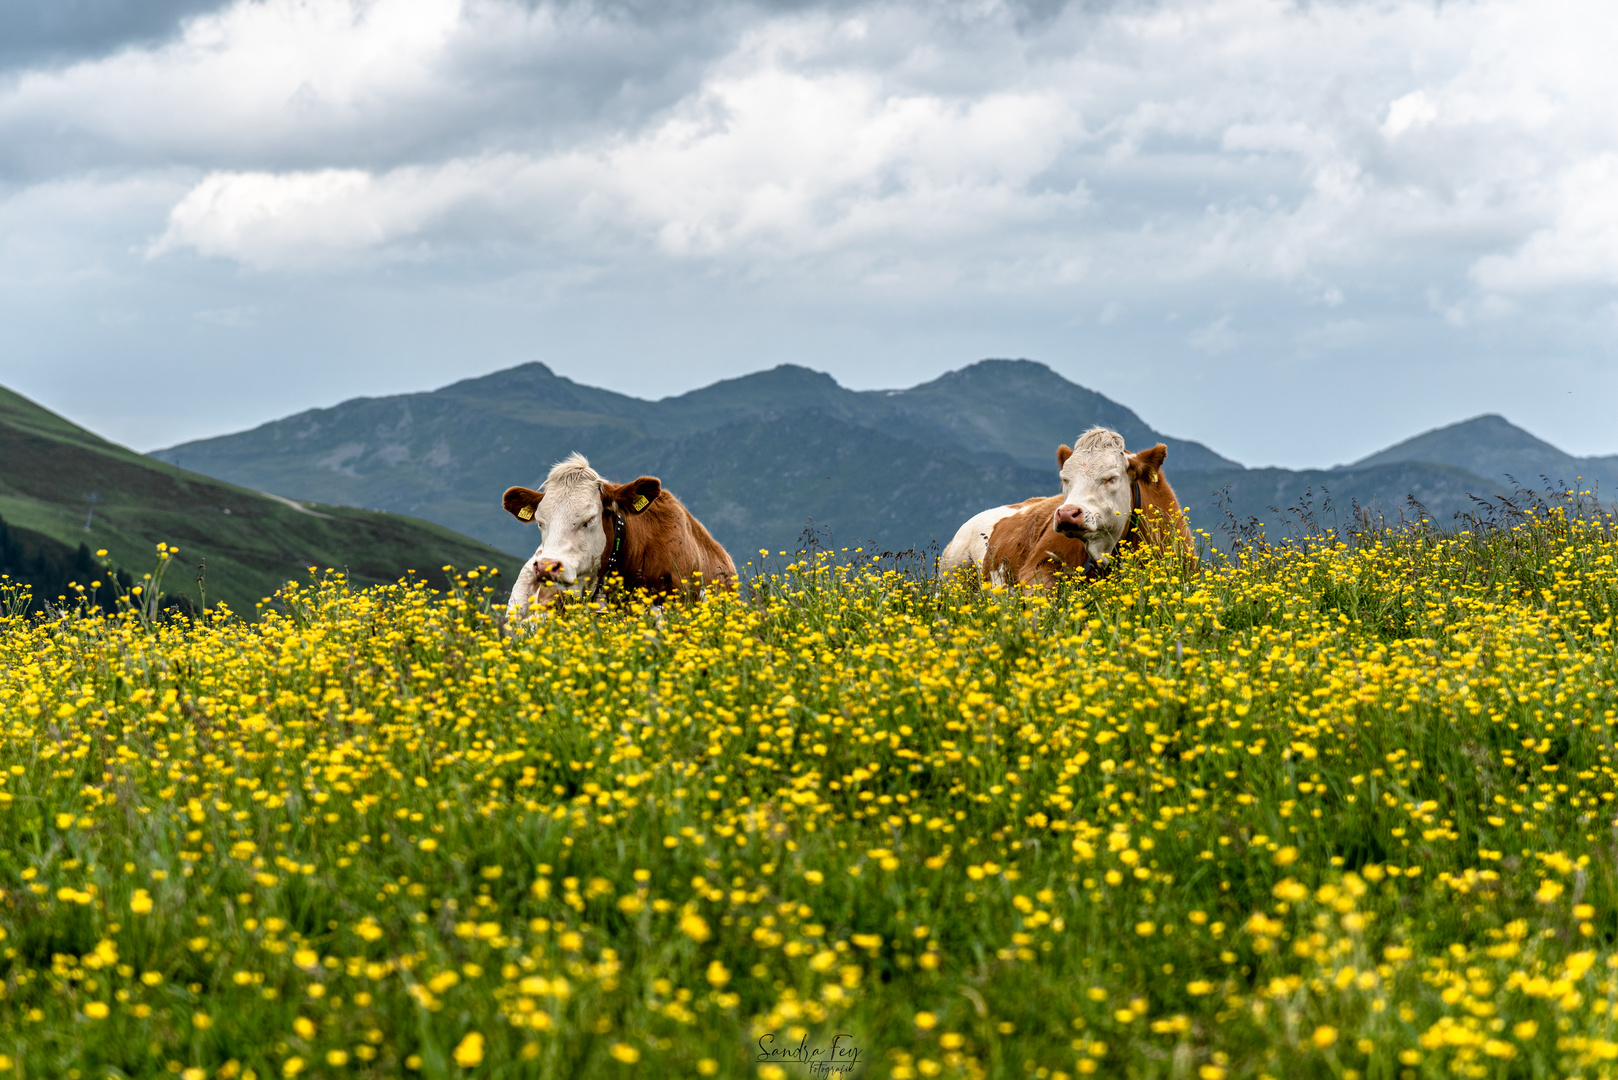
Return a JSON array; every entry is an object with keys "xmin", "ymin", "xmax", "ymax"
[{"xmin": 0, "ymin": 387, "xmax": 519, "ymax": 614}]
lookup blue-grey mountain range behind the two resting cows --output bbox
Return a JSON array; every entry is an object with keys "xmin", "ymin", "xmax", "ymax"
[{"xmin": 152, "ymin": 359, "xmax": 1618, "ymax": 562}]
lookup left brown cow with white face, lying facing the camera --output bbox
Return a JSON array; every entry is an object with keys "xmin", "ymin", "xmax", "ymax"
[{"xmin": 502, "ymin": 453, "xmax": 736, "ymax": 615}]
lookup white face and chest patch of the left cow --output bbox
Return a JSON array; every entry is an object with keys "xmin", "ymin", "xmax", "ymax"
[{"xmin": 508, "ymin": 453, "xmax": 607, "ymax": 614}]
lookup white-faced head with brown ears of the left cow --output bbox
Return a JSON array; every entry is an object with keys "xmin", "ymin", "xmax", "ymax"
[{"xmin": 502, "ymin": 453, "xmax": 663, "ymax": 586}]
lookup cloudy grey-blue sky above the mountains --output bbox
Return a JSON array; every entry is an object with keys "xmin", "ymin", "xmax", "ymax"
[{"xmin": 0, "ymin": 0, "xmax": 1618, "ymax": 468}]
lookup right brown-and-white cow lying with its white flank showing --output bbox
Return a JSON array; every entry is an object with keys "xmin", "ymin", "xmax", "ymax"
[{"xmin": 938, "ymin": 427, "xmax": 1192, "ymax": 585}]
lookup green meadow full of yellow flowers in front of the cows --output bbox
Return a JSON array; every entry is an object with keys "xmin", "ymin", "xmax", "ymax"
[{"xmin": 0, "ymin": 513, "xmax": 1618, "ymax": 1080}]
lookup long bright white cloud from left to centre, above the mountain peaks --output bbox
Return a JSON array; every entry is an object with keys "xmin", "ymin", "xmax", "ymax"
[{"xmin": 149, "ymin": 51, "xmax": 1087, "ymax": 276}]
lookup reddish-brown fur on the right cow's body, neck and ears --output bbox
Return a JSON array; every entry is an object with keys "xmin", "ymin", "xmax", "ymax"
[{"xmin": 982, "ymin": 444, "xmax": 1194, "ymax": 585}]
